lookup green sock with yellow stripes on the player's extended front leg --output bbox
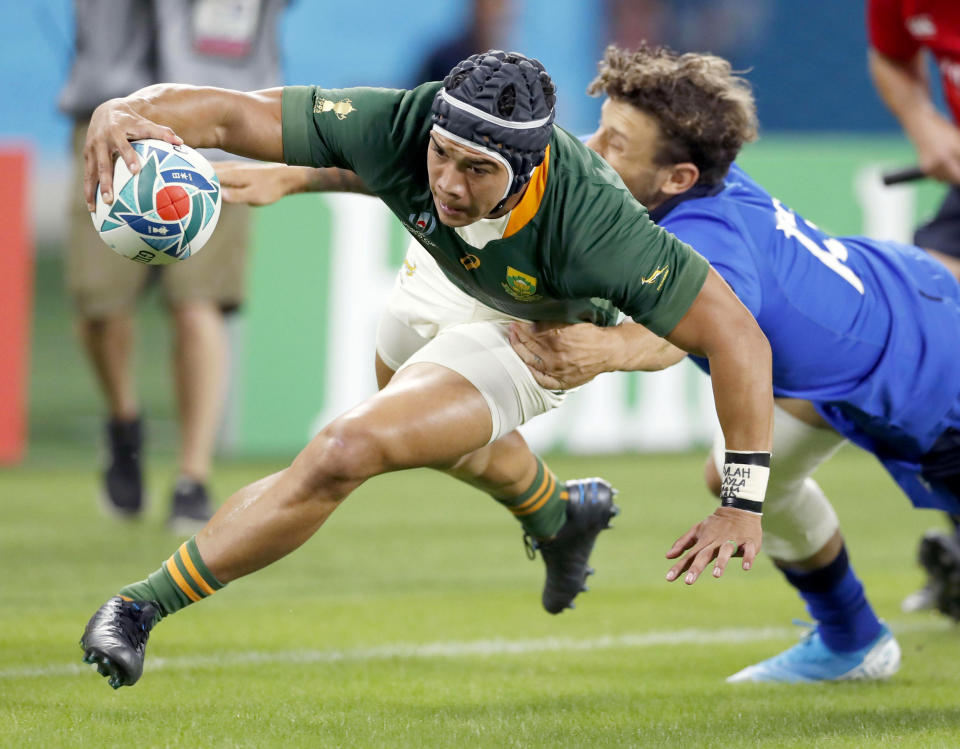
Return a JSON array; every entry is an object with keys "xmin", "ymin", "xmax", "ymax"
[{"xmin": 118, "ymin": 536, "xmax": 224, "ymax": 618}]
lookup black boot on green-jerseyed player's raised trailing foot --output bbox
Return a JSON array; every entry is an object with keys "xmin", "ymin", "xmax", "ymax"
[{"xmin": 524, "ymin": 478, "xmax": 620, "ymax": 614}]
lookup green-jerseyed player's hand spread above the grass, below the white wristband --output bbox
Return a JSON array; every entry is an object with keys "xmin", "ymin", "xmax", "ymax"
[{"xmin": 667, "ymin": 507, "xmax": 763, "ymax": 585}]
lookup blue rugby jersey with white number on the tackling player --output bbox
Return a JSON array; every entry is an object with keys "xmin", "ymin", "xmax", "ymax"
[{"xmin": 651, "ymin": 165, "xmax": 960, "ymax": 512}]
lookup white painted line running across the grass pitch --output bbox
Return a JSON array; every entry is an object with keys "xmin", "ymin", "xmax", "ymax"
[{"xmin": 0, "ymin": 620, "xmax": 953, "ymax": 679}]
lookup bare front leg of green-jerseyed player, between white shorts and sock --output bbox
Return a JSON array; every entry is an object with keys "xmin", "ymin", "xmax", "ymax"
[{"xmin": 197, "ymin": 364, "xmax": 491, "ymax": 583}]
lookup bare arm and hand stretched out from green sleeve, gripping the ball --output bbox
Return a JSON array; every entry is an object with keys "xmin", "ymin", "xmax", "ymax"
[{"xmin": 83, "ymin": 84, "xmax": 283, "ymax": 211}]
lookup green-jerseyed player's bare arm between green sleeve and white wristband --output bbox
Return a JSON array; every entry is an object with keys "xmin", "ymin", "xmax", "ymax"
[{"xmin": 667, "ymin": 268, "xmax": 773, "ymax": 451}]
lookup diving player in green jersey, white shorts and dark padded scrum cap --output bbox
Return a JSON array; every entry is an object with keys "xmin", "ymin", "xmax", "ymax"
[{"xmin": 81, "ymin": 51, "xmax": 773, "ymax": 687}]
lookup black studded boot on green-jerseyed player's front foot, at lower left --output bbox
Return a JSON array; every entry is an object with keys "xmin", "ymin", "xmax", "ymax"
[{"xmin": 80, "ymin": 596, "xmax": 159, "ymax": 689}]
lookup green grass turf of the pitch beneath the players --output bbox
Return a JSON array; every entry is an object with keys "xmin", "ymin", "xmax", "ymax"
[{"xmin": 0, "ymin": 447, "xmax": 960, "ymax": 747}]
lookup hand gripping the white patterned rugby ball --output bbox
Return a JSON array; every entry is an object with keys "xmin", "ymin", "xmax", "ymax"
[{"xmin": 83, "ymin": 97, "xmax": 183, "ymax": 211}]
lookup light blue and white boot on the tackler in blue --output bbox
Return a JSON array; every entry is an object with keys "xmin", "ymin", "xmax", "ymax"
[{"xmin": 727, "ymin": 624, "xmax": 900, "ymax": 684}]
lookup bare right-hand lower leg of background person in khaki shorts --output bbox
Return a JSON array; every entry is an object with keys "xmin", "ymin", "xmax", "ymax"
[{"xmin": 172, "ymin": 301, "xmax": 227, "ymax": 483}]
